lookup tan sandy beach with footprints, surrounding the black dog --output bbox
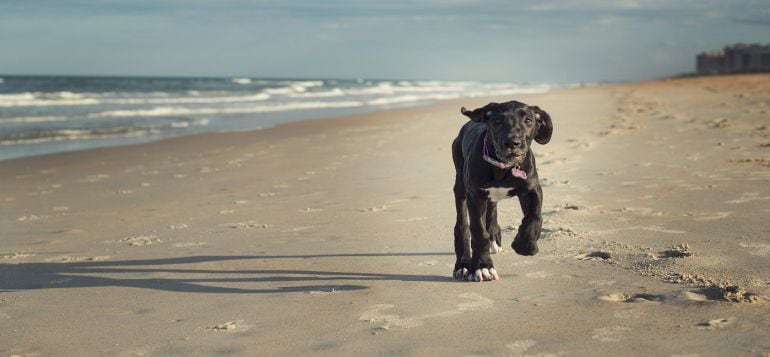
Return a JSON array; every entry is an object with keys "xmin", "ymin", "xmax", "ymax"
[{"xmin": 0, "ymin": 75, "xmax": 770, "ymax": 356}]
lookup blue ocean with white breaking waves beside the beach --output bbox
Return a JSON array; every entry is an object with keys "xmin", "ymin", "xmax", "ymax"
[{"xmin": 0, "ymin": 75, "xmax": 559, "ymax": 160}]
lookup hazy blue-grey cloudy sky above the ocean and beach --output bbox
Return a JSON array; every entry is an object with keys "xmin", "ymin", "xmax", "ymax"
[{"xmin": 0, "ymin": 0, "xmax": 770, "ymax": 83}]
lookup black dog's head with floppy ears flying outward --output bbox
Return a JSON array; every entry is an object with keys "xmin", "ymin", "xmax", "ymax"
[{"xmin": 460, "ymin": 101, "xmax": 553, "ymax": 165}]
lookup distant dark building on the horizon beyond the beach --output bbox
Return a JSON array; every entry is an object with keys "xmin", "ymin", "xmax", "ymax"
[{"xmin": 695, "ymin": 43, "xmax": 770, "ymax": 74}]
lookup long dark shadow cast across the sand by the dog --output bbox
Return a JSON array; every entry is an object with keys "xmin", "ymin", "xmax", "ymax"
[{"xmin": 0, "ymin": 253, "xmax": 452, "ymax": 294}]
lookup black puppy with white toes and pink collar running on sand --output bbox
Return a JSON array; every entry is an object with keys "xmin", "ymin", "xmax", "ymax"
[{"xmin": 452, "ymin": 101, "xmax": 553, "ymax": 281}]
